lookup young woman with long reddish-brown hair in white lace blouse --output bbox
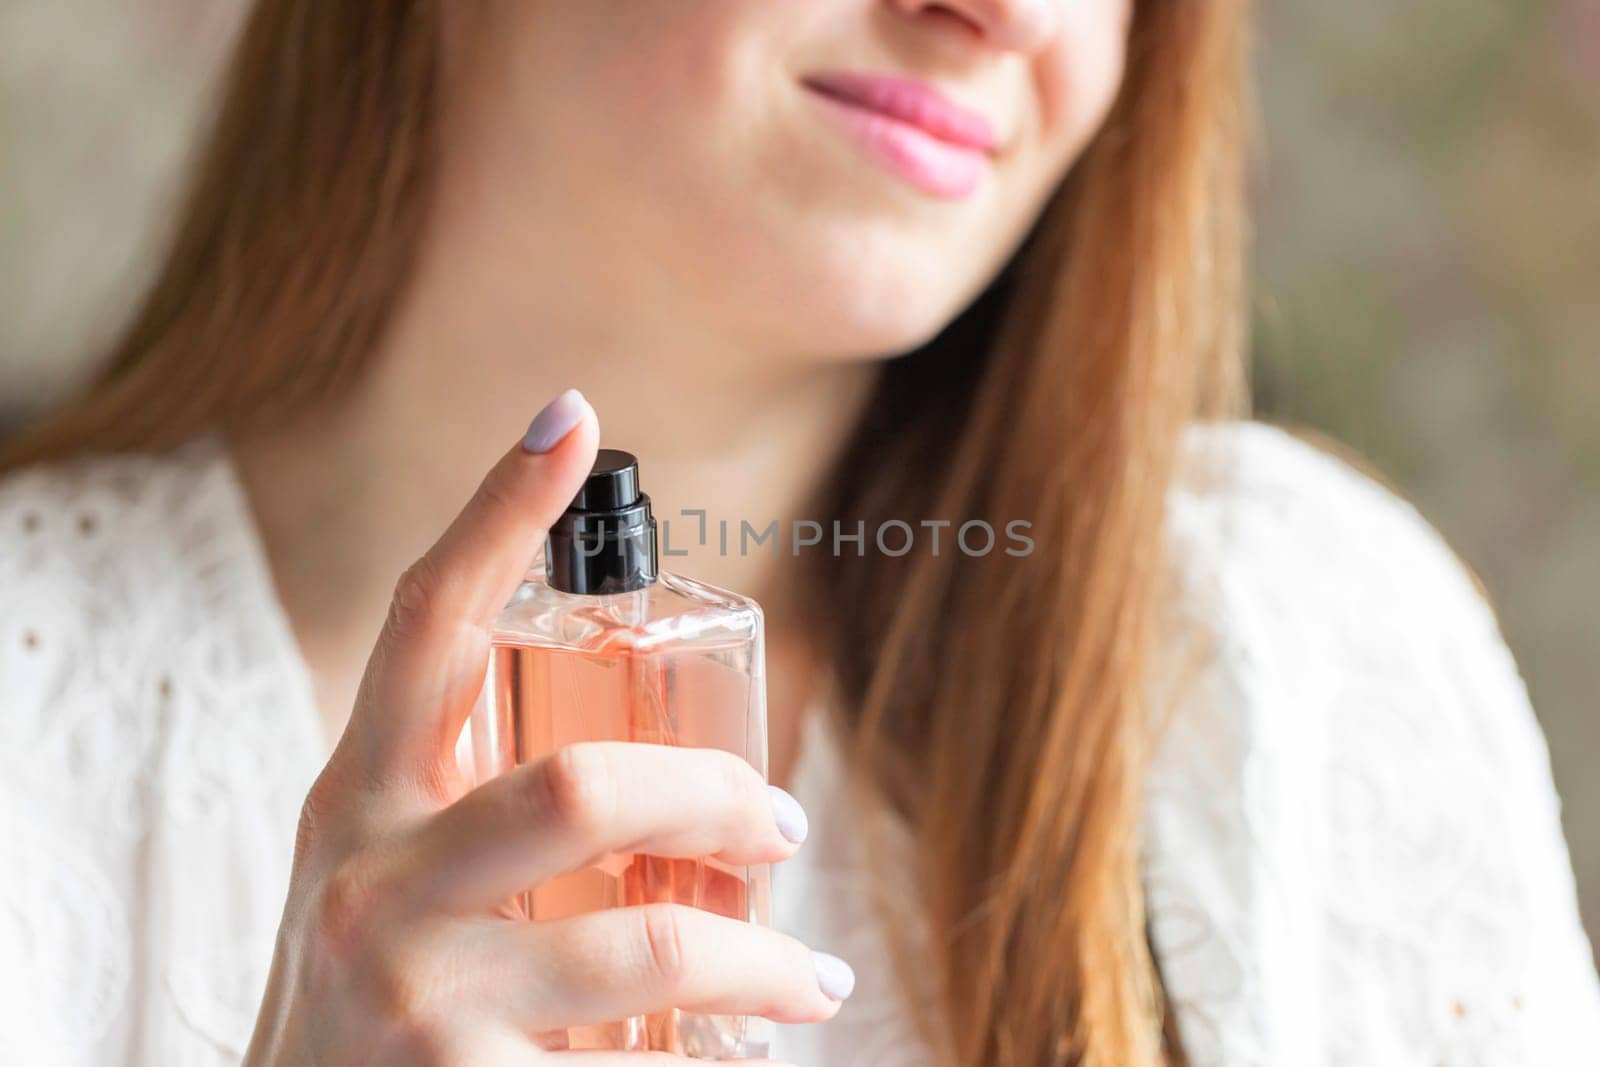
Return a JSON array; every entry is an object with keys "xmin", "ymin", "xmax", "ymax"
[{"xmin": 0, "ymin": 0, "xmax": 1600, "ymax": 1067}]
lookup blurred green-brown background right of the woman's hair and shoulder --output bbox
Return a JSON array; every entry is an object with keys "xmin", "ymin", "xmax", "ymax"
[{"xmin": 1254, "ymin": 0, "xmax": 1600, "ymax": 937}]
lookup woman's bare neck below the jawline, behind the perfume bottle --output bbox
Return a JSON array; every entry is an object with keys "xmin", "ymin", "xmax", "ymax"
[{"xmin": 235, "ymin": 60, "xmax": 878, "ymax": 769}]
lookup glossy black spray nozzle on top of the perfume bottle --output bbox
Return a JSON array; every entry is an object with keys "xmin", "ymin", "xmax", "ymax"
[{"xmin": 544, "ymin": 448, "xmax": 658, "ymax": 597}]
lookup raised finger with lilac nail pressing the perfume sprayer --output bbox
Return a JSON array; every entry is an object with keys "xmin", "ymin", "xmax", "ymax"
[{"xmin": 350, "ymin": 389, "xmax": 600, "ymax": 781}]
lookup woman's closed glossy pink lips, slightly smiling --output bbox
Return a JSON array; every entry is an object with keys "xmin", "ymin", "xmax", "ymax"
[{"xmin": 803, "ymin": 72, "xmax": 998, "ymax": 198}]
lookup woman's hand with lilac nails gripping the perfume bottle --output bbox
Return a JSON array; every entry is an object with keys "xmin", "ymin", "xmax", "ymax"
[{"xmin": 246, "ymin": 392, "xmax": 850, "ymax": 1067}]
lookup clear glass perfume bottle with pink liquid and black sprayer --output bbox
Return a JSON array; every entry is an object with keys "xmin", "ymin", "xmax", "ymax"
[{"xmin": 469, "ymin": 448, "xmax": 773, "ymax": 1059}]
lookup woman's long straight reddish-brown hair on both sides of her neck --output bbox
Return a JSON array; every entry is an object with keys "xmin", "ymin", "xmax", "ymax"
[{"xmin": 0, "ymin": 0, "xmax": 1246, "ymax": 1067}]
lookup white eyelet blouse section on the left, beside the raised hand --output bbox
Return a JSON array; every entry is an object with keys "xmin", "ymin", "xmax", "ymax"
[{"xmin": 0, "ymin": 438, "xmax": 325, "ymax": 1065}]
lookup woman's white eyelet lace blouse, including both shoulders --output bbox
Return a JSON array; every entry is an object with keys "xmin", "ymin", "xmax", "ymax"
[{"xmin": 0, "ymin": 422, "xmax": 1600, "ymax": 1067}]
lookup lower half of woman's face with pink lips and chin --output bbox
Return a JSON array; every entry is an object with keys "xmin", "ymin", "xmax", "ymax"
[{"xmin": 478, "ymin": 0, "xmax": 1133, "ymax": 363}]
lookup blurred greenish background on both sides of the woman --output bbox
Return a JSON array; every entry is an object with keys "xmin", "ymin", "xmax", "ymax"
[{"xmin": 0, "ymin": 0, "xmax": 1600, "ymax": 959}]
